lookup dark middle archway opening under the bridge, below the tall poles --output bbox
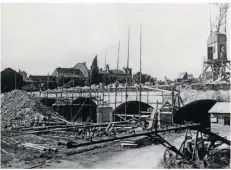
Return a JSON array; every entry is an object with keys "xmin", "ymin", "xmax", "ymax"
[{"xmin": 113, "ymin": 101, "xmax": 153, "ymax": 121}]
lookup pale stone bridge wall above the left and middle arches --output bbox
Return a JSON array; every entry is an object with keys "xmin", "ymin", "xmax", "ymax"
[{"xmin": 32, "ymin": 88, "xmax": 176, "ymax": 109}]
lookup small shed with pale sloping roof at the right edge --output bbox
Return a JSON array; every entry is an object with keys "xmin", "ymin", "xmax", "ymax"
[{"xmin": 209, "ymin": 102, "xmax": 231, "ymax": 125}]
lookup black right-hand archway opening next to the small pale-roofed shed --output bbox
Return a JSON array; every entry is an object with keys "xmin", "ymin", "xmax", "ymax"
[{"xmin": 173, "ymin": 100, "xmax": 217, "ymax": 128}]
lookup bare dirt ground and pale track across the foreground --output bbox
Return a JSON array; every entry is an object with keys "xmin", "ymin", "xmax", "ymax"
[{"xmin": 1, "ymin": 125, "xmax": 230, "ymax": 169}]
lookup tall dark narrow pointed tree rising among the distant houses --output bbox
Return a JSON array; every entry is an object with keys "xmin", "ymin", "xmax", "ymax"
[{"xmin": 90, "ymin": 55, "xmax": 99, "ymax": 84}]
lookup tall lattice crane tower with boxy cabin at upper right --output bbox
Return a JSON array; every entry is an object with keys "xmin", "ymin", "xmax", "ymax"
[{"xmin": 203, "ymin": 3, "xmax": 230, "ymax": 82}]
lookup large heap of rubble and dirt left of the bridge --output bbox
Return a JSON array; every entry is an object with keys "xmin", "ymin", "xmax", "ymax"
[{"xmin": 1, "ymin": 90, "xmax": 67, "ymax": 127}]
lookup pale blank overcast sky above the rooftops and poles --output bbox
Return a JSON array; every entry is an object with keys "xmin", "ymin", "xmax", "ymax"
[{"xmin": 1, "ymin": 3, "xmax": 230, "ymax": 79}]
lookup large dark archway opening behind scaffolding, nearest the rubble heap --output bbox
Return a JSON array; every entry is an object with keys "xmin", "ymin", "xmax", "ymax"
[{"xmin": 53, "ymin": 97, "xmax": 97, "ymax": 123}]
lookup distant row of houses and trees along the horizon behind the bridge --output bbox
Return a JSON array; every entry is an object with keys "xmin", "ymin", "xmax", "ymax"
[{"xmin": 1, "ymin": 56, "xmax": 206, "ymax": 92}]
